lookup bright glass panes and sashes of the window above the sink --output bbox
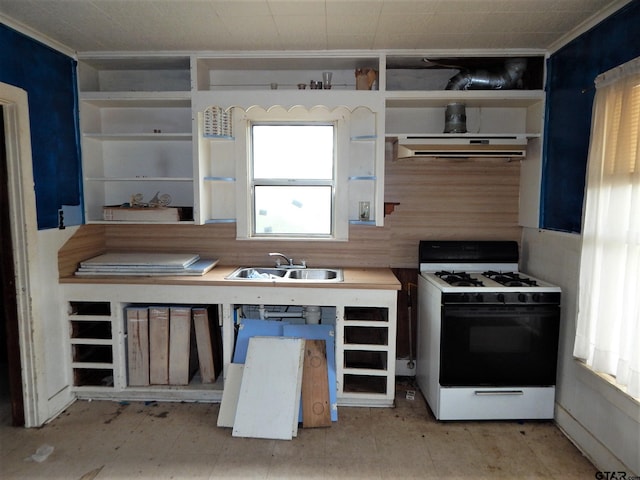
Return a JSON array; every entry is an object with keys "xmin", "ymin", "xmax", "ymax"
[{"xmin": 251, "ymin": 123, "xmax": 336, "ymax": 238}]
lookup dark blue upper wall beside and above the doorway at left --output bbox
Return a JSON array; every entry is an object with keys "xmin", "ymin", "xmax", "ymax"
[{"xmin": 0, "ymin": 24, "xmax": 82, "ymax": 230}]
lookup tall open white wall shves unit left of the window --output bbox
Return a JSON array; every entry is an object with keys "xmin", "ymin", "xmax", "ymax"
[{"xmin": 78, "ymin": 56, "xmax": 194, "ymax": 223}]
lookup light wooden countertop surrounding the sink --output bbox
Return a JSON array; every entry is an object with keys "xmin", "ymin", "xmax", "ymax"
[{"xmin": 60, "ymin": 265, "xmax": 402, "ymax": 290}]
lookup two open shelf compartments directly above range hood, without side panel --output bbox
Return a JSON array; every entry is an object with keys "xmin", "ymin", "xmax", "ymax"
[{"xmin": 385, "ymin": 55, "xmax": 544, "ymax": 137}]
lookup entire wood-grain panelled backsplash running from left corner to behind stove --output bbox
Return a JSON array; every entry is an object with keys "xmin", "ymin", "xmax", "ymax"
[{"xmin": 61, "ymin": 155, "xmax": 526, "ymax": 274}]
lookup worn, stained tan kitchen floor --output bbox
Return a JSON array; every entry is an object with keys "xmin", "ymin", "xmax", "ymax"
[{"xmin": 0, "ymin": 381, "xmax": 596, "ymax": 480}]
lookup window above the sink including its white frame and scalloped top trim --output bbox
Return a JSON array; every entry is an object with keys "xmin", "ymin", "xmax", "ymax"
[{"xmin": 234, "ymin": 105, "xmax": 352, "ymax": 241}]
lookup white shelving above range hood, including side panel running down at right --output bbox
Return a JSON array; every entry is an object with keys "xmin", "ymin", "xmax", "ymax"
[{"xmin": 384, "ymin": 51, "xmax": 546, "ymax": 228}]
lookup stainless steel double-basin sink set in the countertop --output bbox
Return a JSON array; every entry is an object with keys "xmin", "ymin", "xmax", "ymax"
[{"xmin": 225, "ymin": 267, "xmax": 344, "ymax": 283}]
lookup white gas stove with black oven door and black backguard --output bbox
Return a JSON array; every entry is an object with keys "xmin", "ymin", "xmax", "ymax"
[{"xmin": 416, "ymin": 241, "xmax": 561, "ymax": 420}]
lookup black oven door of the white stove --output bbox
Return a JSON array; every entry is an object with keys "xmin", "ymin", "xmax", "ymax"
[{"xmin": 440, "ymin": 304, "xmax": 560, "ymax": 386}]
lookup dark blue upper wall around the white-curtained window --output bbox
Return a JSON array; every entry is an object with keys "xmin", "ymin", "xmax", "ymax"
[{"xmin": 540, "ymin": 0, "xmax": 640, "ymax": 232}]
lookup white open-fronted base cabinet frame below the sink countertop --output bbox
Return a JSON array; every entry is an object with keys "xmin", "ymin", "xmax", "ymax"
[{"xmin": 61, "ymin": 282, "xmax": 397, "ymax": 407}]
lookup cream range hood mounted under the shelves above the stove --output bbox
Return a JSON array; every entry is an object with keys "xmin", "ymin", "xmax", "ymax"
[{"xmin": 394, "ymin": 134, "xmax": 527, "ymax": 159}]
